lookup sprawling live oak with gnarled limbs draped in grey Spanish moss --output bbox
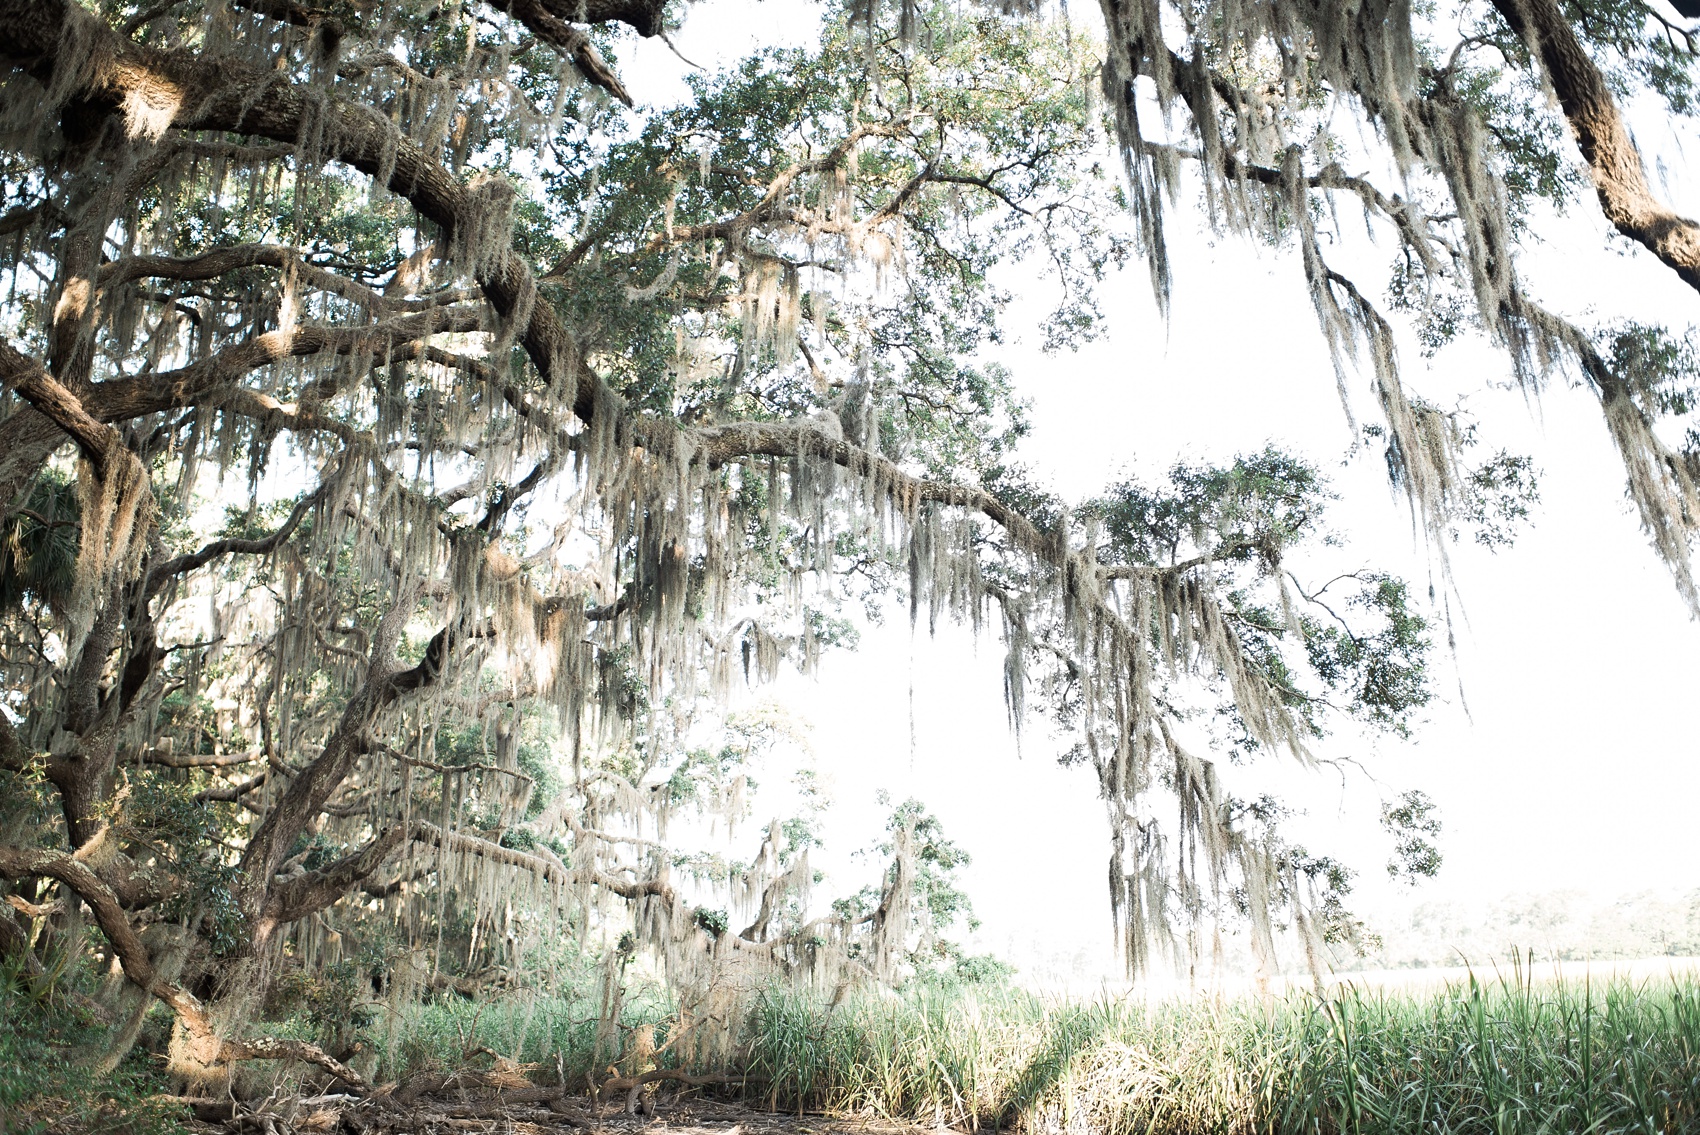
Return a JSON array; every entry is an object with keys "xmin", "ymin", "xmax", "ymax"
[{"xmin": 0, "ymin": 0, "xmax": 1700, "ymax": 1087}]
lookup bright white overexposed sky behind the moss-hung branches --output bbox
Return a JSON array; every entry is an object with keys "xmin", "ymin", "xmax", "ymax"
[{"xmin": 605, "ymin": 0, "xmax": 1700, "ymax": 974}]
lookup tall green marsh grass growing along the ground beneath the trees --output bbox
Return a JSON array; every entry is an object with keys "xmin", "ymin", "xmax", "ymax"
[{"xmin": 379, "ymin": 967, "xmax": 1700, "ymax": 1135}]
